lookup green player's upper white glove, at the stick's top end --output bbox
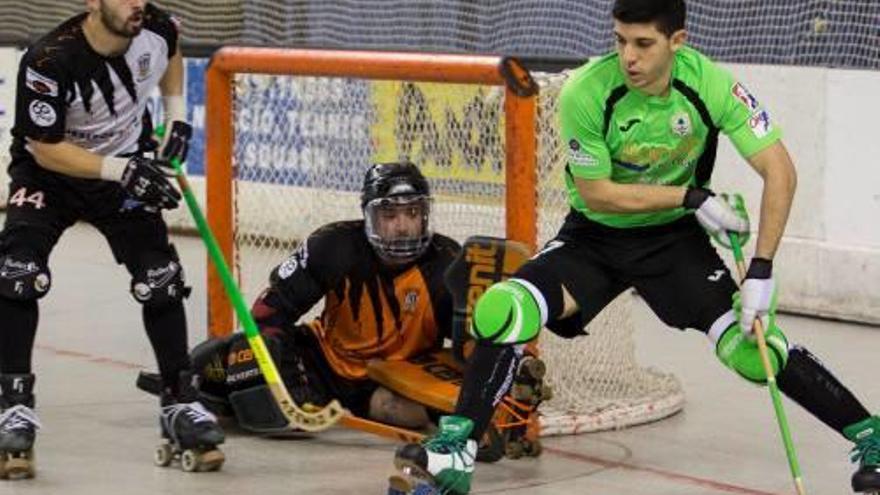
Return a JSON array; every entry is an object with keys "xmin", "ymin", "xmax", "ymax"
[{"xmin": 682, "ymin": 187, "xmax": 750, "ymax": 249}]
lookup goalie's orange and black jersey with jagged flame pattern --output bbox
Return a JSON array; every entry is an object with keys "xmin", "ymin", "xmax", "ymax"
[{"xmin": 253, "ymin": 220, "xmax": 461, "ymax": 380}]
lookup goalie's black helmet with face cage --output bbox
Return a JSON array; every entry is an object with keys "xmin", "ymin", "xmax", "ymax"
[{"xmin": 361, "ymin": 162, "xmax": 433, "ymax": 264}]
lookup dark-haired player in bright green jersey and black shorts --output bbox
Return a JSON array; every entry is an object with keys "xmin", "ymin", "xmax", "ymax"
[{"xmin": 390, "ymin": 0, "xmax": 880, "ymax": 494}]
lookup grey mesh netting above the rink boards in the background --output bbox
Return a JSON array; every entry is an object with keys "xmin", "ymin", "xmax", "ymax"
[{"xmin": 0, "ymin": 0, "xmax": 880, "ymax": 68}]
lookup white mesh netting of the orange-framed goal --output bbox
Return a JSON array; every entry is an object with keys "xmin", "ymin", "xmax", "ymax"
[{"xmin": 227, "ymin": 69, "xmax": 684, "ymax": 434}]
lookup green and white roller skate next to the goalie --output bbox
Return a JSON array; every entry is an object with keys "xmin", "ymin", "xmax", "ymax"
[{"xmin": 388, "ymin": 416, "xmax": 477, "ymax": 495}]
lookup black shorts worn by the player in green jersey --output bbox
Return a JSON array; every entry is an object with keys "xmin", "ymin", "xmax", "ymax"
[{"xmin": 516, "ymin": 211, "xmax": 737, "ymax": 337}]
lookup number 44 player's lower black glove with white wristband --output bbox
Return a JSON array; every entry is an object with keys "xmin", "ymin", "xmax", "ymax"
[{"xmin": 101, "ymin": 156, "xmax": 180, "ymax": 209}]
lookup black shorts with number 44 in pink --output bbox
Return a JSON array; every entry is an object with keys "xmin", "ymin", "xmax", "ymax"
[{"xmin": 0, "ymin": 164, "xmax": 176, "ymax": 272}]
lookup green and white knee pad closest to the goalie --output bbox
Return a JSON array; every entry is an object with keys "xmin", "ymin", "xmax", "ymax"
[{"xmin": 471, "ymin": 278, "xmax": 547, "ymax": 344}]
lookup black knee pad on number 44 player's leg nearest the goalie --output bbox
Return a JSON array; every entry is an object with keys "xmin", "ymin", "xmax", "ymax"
[{"xmin": 131, "ymin": 246, "xmax": 190, "ymax": 308}]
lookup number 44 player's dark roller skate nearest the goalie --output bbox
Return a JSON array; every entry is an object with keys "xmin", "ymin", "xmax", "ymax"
[{"xmin": 155, "ymin": 371, "xmax": 226, "ymax": 472}]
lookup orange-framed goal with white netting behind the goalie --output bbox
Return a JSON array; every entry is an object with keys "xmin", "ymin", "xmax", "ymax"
[{"xmin": 206, "ymin": 49, "xmax": 684, "ymax": 434}]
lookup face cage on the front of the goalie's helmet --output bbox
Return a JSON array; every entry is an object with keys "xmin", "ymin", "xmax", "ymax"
[{"xmin": 364, "ymin": 194, "xmax": 433, "ymax": 264}]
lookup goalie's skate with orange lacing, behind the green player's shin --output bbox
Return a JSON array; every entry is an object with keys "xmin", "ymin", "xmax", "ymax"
[{"xmin": 493, "ymin": 355, "xmax": 553, "ymax": 459}]
